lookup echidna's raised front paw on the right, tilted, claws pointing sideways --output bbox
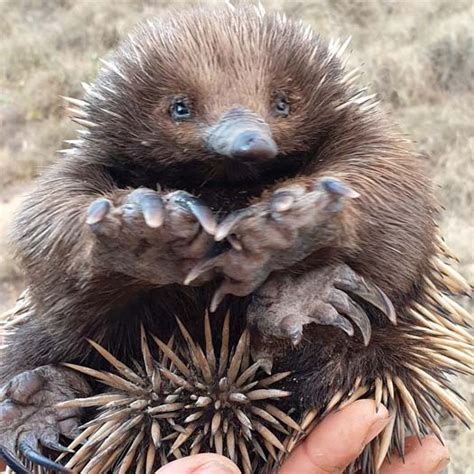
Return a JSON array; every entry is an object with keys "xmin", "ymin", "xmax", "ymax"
[{"xmin": 186, "ymin": 177, "xmax": 359, "ymax": 309}]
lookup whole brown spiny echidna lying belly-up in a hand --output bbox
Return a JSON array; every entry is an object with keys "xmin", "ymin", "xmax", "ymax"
[{"xmin": 0, "ymin": 6, "xmax": 472, "ymax": 474}]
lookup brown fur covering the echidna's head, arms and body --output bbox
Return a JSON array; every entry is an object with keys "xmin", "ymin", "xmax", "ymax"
[{"xmin": 0, "ymin": 3, "xmax": 435, "ymax": 468}]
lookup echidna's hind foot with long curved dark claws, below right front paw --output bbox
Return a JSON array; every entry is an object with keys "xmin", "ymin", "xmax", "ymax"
[{"xmin": 247, "ymin": 264, "xmax": 396, "ymax": 356}]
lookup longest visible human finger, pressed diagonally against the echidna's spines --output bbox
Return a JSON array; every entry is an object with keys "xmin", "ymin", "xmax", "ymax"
[{"xmin": 279, "ymin": 400, "xmax": 390, "ymax": 474}]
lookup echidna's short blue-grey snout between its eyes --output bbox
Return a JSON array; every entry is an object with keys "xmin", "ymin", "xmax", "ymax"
[{"xmin": 207, "ymin": 108, "xmax": 278, "ymax": 162}]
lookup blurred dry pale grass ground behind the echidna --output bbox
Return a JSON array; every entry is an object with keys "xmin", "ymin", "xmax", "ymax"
[{"xmin": 0, "ymin": 0, "xmax": 474, "ymax": 473}]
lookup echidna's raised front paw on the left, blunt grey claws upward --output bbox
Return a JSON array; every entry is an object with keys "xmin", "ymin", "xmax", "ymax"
[{"xmin": 86, "ymin": 188, "xmax": 217, "ymax": 284}]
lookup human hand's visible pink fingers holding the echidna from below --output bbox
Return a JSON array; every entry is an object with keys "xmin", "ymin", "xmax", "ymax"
[{"xmin": 156, "ymin": 400, "xmax": 449, "ymax": 474}]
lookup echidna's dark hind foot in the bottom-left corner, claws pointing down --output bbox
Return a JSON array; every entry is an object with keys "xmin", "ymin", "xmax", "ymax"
[{"xmin": 0, "ymin": 365, "xmax": 89, "ymax": 473}]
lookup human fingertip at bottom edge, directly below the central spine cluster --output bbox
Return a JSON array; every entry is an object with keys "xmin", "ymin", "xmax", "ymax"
[{"xmin": 156, "ymin": 453, "xmax": 240, "ymax": 474}]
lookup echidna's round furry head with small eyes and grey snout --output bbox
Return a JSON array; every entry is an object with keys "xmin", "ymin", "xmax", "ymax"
[{"xmin": 83, "ymin": 7, "xmax": 348, "ymax": 183}]
